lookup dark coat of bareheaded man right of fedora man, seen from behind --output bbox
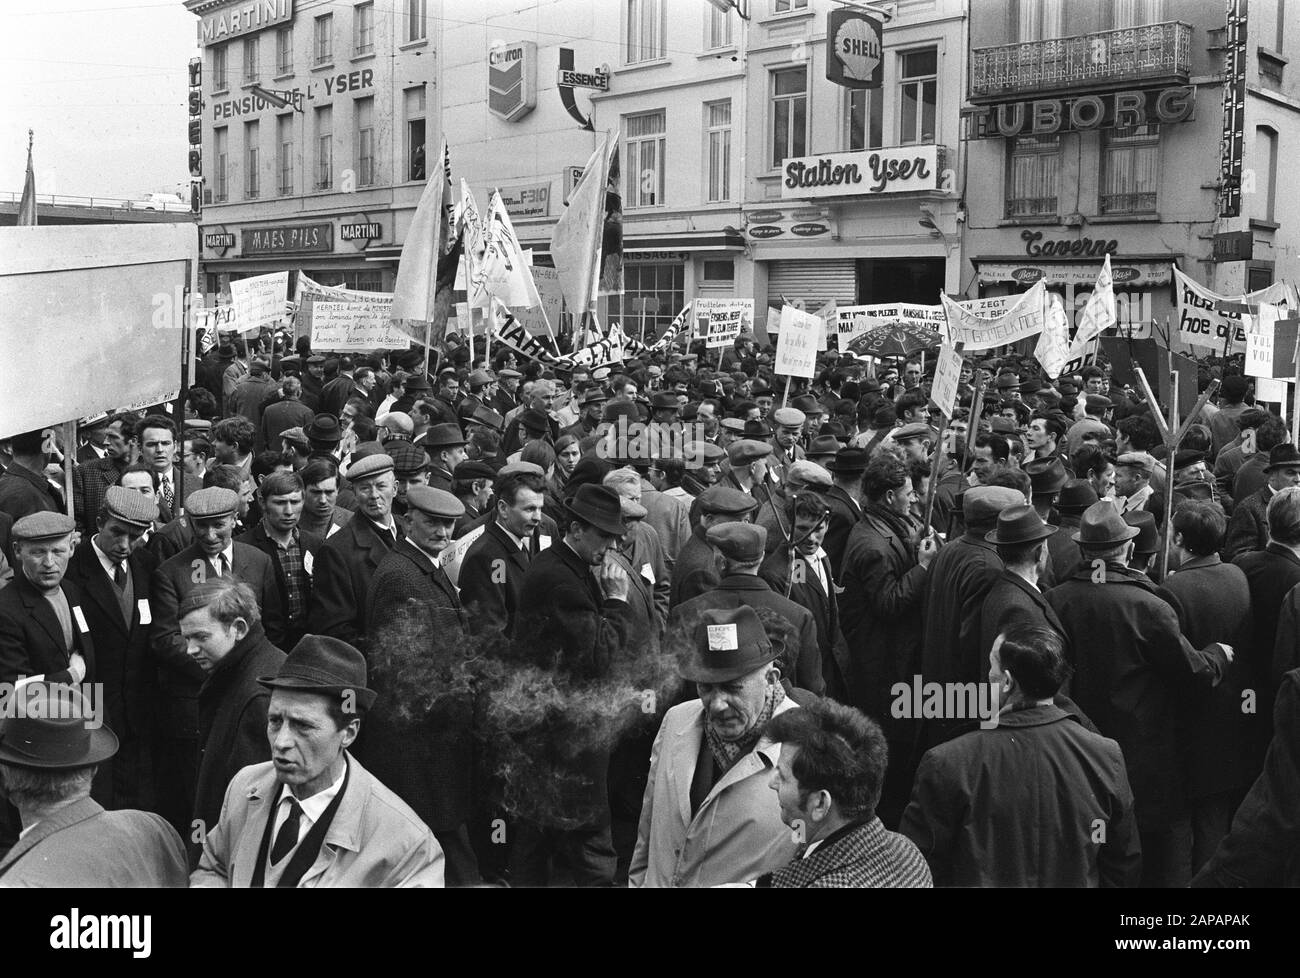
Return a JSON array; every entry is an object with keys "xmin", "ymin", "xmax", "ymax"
[{"xmin": 1162, "ymin": 554, "xmax": 1268, "ymax": 799}]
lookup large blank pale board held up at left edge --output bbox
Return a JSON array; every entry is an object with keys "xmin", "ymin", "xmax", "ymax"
[{"xmin": 0, "ymin": 224, "xmax": 199, "ymax": 438}]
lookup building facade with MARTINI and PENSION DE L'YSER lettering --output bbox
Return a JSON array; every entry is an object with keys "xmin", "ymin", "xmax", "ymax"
[{"xmin": 185, "ymin": 0, "xmax": 438, "ymax": 294}]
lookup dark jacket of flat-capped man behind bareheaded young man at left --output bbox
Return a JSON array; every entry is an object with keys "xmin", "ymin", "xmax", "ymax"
[{"xmin": 150, "ymin": 541, "xmax": 285, "ymax": 740}]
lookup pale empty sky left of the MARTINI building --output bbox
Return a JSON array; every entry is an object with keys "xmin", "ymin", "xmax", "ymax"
[{"xmin": 0, "ymin": 0, "xmax": 198, "ymax": 200}]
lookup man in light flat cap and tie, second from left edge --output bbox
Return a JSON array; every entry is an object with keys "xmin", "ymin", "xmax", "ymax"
[{"xmin": 68, "ymin": 485, "xmax": 159, "ymax": 809}]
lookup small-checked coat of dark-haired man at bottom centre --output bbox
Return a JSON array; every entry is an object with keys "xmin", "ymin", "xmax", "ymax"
[{"xmin": 759, "ymin": 818, "xmax": 935, "ymax": 888}]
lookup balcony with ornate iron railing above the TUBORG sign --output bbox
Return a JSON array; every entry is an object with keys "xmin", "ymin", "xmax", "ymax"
[{"xmin": 970, "ymin": 21, "xmax": 1192, "ymax": 101}]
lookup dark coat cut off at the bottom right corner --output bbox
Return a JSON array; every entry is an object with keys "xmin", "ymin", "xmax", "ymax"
[{"xmin": 1192, "ymin": 670, "xmax": 1300, "ymax": 887}]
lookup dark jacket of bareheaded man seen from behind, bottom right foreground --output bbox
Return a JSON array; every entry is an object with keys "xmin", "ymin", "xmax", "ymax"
[{"xmin": 900, "ymin": 705, "xmax": 1141, "ymax": 887}]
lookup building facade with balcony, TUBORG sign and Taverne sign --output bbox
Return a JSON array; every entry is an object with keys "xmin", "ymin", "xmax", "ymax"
[{"xmin": 963, "ymin": 0, "xmax": 1300, "ymax": 337}]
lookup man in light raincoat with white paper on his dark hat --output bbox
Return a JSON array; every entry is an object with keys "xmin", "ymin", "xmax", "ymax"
[{"xmin": 628, "ymin": 606, "xmax": 798, "ymax": 887}]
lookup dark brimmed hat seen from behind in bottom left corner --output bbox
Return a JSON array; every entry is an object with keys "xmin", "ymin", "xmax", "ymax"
[{"xmin": 0, "ymin": 681, "xmax": 117, "ymax": 771}]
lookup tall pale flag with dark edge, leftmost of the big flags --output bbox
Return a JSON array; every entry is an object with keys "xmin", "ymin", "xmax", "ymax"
[{"xmin": 391, "ymin": 139, "xmax": 460, "ymax": 345}]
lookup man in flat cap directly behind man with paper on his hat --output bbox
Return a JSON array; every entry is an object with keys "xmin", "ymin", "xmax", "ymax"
[{"xmin": 668, "ymin": 523, "xmax": 826, "ymax": 696}]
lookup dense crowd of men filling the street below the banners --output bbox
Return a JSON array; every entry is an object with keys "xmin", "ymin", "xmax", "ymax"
[{"xmin": 0, "ymin": 338, "xmax": 1300, "ymax": 887}]
